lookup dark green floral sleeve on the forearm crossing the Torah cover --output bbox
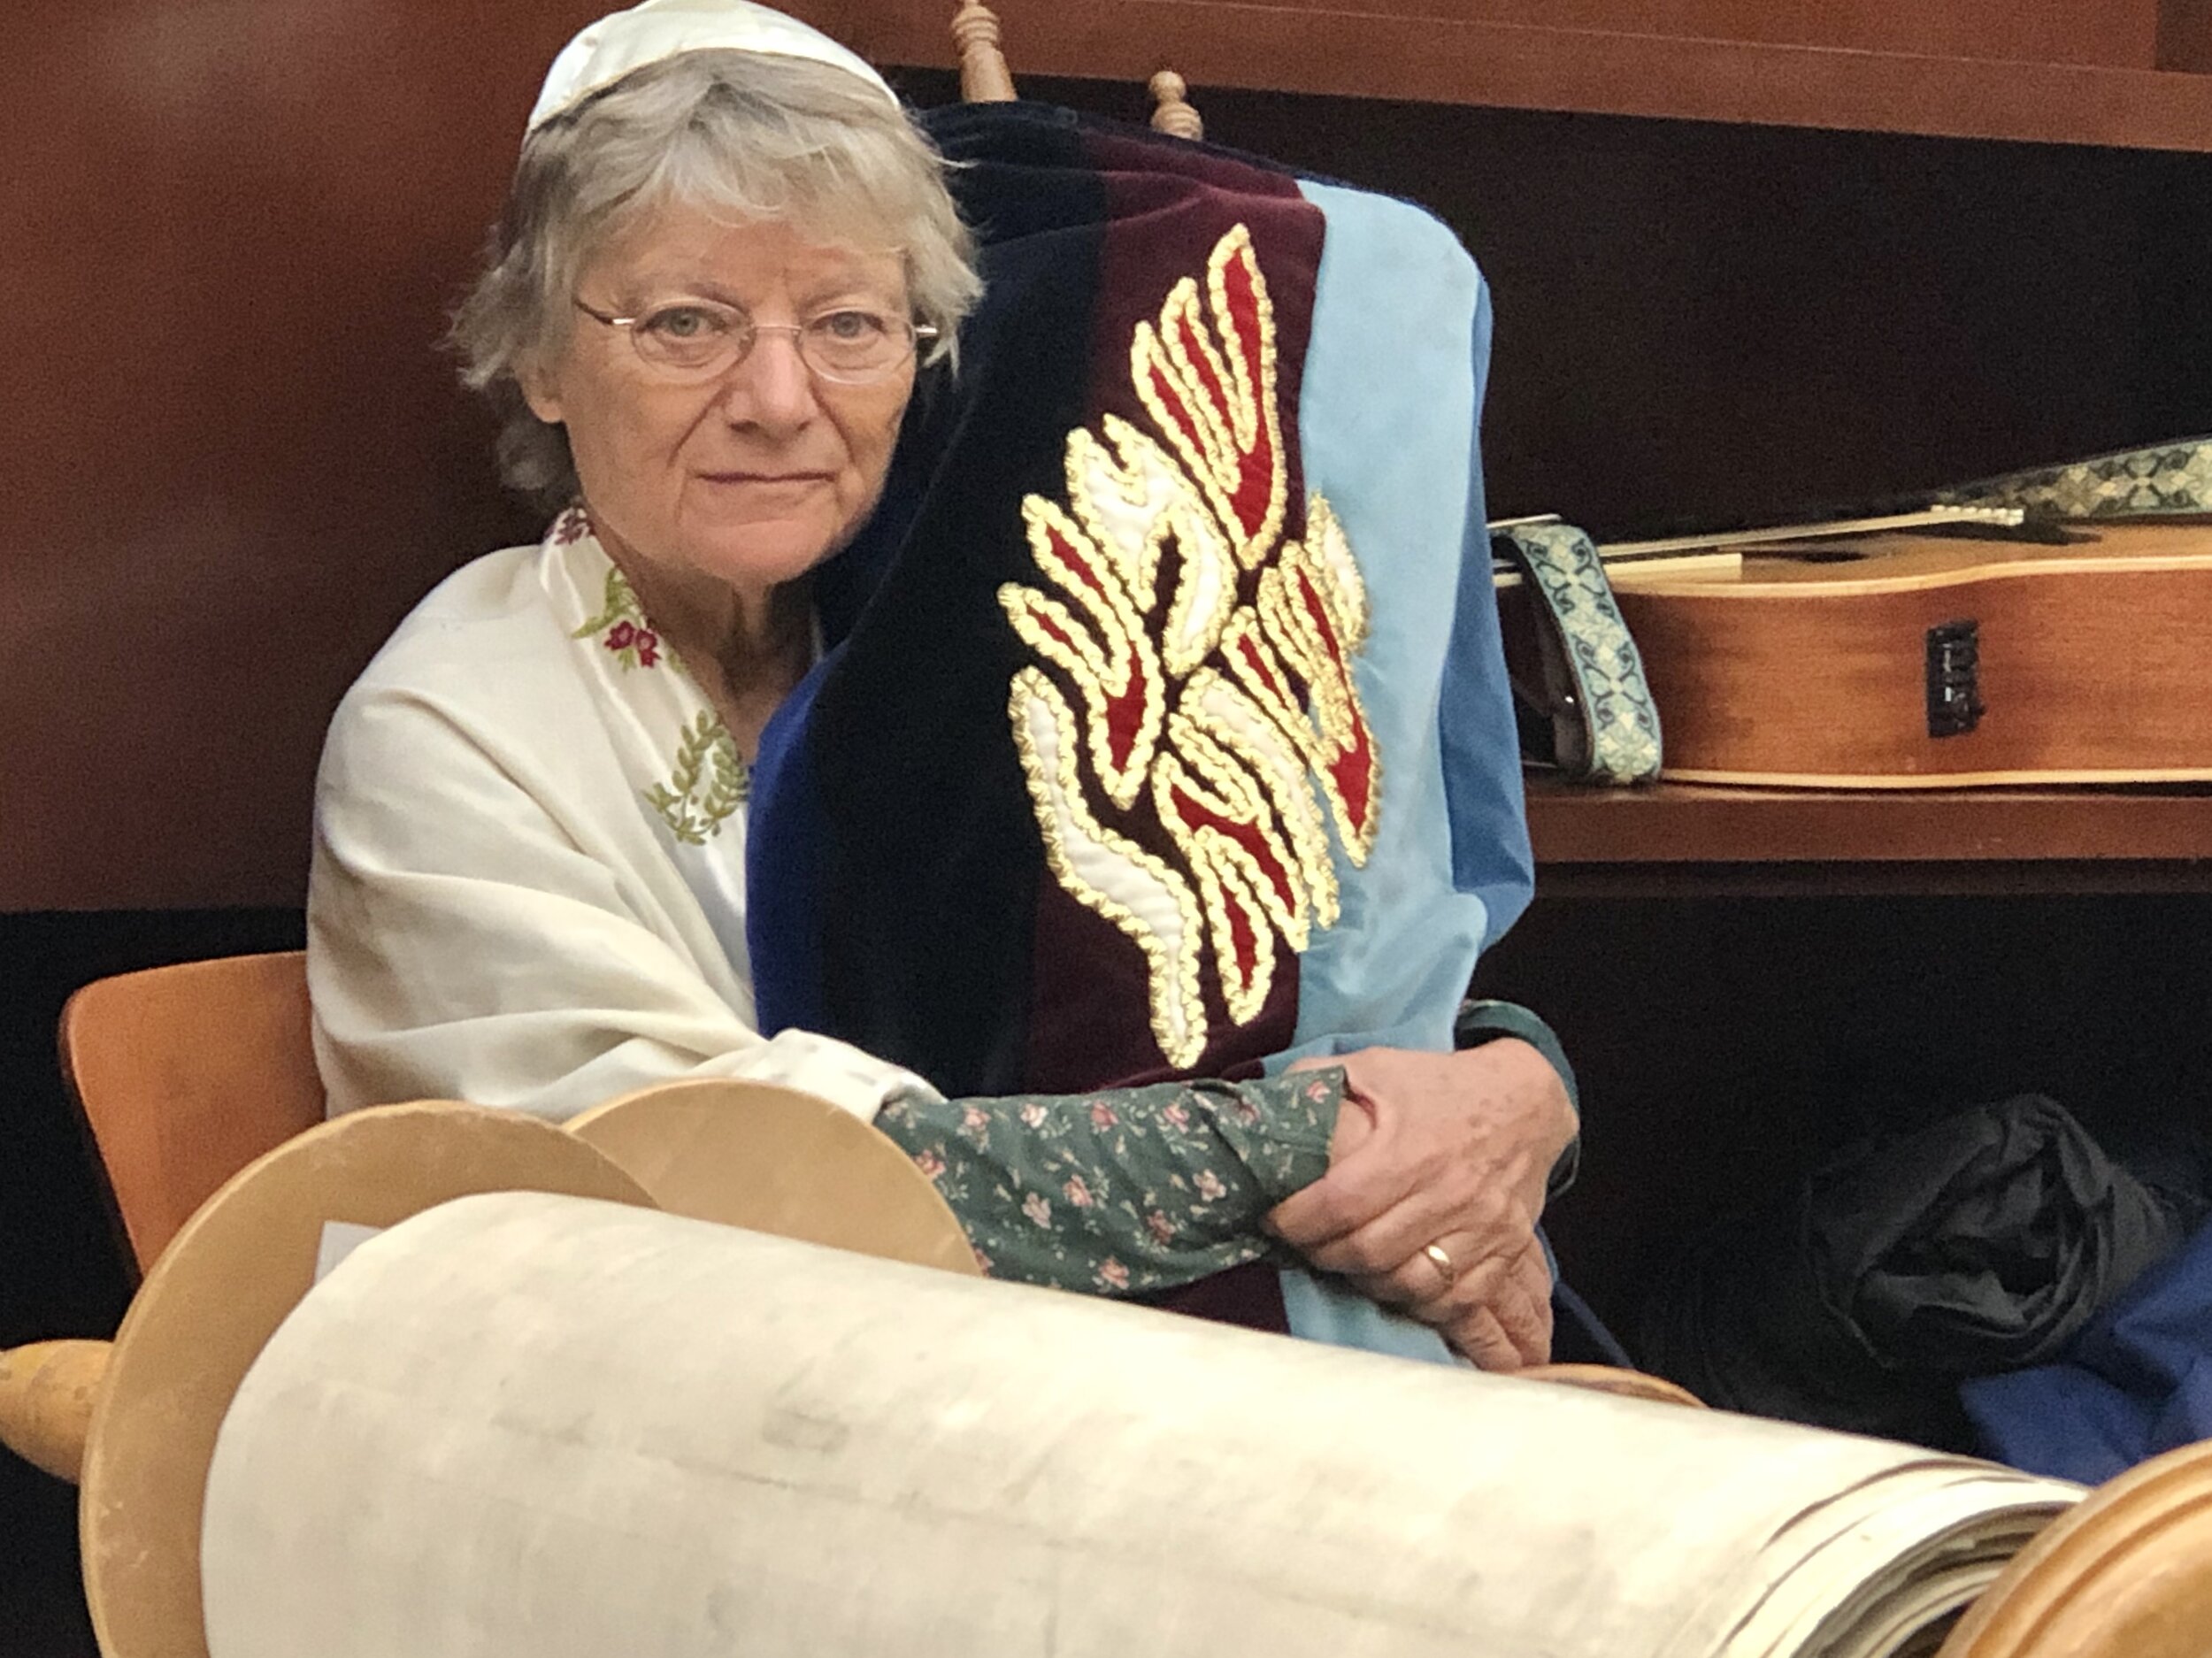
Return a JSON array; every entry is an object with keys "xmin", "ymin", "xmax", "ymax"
[{"xmin": 876, "ymin": 1068, "xmax": 1345, "ymax": 1295}]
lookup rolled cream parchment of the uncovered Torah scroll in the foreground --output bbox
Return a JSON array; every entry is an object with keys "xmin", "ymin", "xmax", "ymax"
[{"xmin": 202, "ymin": 1194, "xmax": 2079, "ymax": 1658}]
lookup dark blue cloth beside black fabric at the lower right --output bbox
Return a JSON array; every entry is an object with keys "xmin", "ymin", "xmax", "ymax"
[{"xmin": 1960, "ymin": 1227, "xmax": 2212, "ymax": 1484}]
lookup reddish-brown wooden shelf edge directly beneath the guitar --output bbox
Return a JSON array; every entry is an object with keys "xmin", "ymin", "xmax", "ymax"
[{"xmin": 1529, "ymin": 779, "xmax": 2212, "ymax": 893}]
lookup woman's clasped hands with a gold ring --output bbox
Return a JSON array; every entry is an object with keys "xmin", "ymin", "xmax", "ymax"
[{"xmin": 1268, "ymin": 1037, "xmax": 1575, "ymax": 1370}]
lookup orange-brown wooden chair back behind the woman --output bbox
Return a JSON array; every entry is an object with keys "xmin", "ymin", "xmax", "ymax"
[{"xmin": 62, "ymin": 950, "xmax": 323, "ymax": 1271}]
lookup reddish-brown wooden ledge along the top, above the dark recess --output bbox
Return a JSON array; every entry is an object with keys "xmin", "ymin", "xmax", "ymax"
[{"xmin": 823, "ymin": 0, "xmax": 2212, "ymax": 150}]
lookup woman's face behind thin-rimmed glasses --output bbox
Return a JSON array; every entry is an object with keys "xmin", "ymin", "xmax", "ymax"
[{"xmin": 525, "ymin": 205, "xmax": 914, "ymax": 599}]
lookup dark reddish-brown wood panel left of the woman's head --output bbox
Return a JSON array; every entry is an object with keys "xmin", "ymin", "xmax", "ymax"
[{"xmin": 0, "ymin": 0, "xmax": 595, "ymax": 909}]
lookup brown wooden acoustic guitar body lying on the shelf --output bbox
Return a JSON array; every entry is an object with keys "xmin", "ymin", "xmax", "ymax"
[{"xmin": 1610, "ymin": 522, "xmax": 2212, "ymax": 789}]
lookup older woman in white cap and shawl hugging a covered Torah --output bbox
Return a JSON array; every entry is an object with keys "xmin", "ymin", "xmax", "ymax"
[{"xmin": 310, "ymin": 0, "xmax": 1575, "ymax": 1369}]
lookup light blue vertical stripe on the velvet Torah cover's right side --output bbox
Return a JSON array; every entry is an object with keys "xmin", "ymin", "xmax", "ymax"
[{"xmin": 1270, "ymin": 181, "xmax": 1535, "ymax": 1364}]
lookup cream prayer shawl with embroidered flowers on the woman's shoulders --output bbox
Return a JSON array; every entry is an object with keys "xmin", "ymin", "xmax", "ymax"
[{"xmin": 308, "ymin": 510, "xmax": 936, "ymax": 1118}]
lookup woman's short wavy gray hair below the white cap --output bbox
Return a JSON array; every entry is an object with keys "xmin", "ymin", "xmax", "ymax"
[{"xmin": 451, "ymin": 50, "xmax": 982, "ymax": 506}]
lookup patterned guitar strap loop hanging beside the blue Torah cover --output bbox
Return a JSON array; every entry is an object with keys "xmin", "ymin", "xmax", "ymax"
[{"xmin": 1491, "ymin": 524, "xmax": 1659, "ymax": 785}]
